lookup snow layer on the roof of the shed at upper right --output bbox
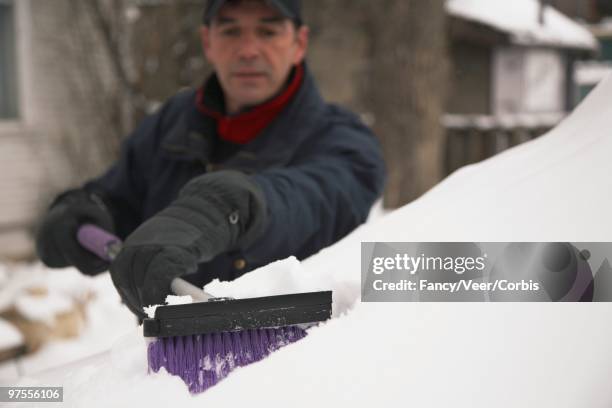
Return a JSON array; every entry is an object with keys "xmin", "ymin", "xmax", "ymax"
[{"xmin": 446, "ymin": 0, "xmax": 598, "ymax": 50}]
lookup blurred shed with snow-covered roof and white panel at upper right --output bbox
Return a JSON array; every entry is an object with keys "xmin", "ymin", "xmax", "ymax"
[{"xmin": 444, "ymin": 0, "xmax": 598, "ymax": 172}]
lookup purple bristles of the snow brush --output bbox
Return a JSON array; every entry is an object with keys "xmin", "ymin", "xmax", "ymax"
[{"xmin": 147, "ymin": 327, "xmax": 306, "ymax": 394}]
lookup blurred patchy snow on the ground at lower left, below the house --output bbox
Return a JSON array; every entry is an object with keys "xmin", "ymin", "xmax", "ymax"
[{"xmin": 0, "ymin": 263, "xmax": 136, "ymax": 385}]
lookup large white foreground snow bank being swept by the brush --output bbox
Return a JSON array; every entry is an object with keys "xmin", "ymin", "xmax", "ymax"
[{"xmin": 5, "ymin": 74, "xmax": 612, "ymax": 408}]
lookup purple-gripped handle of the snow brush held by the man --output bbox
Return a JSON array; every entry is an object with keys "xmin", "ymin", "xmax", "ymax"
[{"xmin": 77, "ymin": 224, "xmax": 214, "ymax": 302}]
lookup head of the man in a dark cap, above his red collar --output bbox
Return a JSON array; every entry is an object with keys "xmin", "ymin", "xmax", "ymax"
[{"xmin": 201, "ymin": 0, "xmax": 308, "ymax": 113}]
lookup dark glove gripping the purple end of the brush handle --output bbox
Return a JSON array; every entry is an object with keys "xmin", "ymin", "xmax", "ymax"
[{"xmin": 36, "ymin": 189, "xmax": 114, "ymax": 275}]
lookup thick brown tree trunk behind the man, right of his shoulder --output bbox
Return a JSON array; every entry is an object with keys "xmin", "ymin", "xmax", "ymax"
[{"xmin": 366, "ymin": 0, "xmax": 448, "ymax": 208}]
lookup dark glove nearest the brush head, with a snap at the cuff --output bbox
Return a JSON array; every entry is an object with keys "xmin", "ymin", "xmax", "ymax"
[{"xmin": 110, "ymin": 171, "xmax": 267, "ymax": 317}]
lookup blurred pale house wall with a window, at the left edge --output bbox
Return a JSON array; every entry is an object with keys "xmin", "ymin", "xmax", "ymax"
[{"xmin": 0, "ymin": 0, "xmax": 119, "ymax": 260}]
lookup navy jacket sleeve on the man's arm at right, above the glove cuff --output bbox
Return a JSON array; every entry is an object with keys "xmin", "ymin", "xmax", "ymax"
[{"xmin": 244, "ymin": 117, "xmax": 385, "ymax": 264}]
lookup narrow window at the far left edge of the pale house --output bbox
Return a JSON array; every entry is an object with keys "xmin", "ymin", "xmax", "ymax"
[{"xmin": 0, "ymin": 0, "xmax": 18, "ymax": 120}]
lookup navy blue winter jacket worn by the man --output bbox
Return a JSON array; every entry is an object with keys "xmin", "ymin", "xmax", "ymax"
[{"xmin": 87, "ymin": 65, "xmax": 385, "ymax": 285}]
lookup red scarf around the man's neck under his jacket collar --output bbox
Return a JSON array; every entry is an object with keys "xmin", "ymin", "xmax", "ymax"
[{"xmin": 196, "ymin": 65, "xmax": 304, "ymax": 144}]
